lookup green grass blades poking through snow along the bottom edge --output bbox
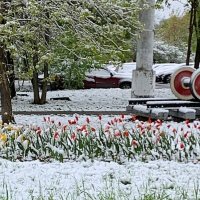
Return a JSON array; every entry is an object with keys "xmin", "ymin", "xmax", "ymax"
[{"xmin": 0, "ymin": 178, "xmax": 200, "ymax": 200}]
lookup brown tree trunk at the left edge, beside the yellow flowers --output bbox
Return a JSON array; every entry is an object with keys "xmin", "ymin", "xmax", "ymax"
[{"xmin": 0, "ymin": 47, "xmax": 14, "ymax": 123}]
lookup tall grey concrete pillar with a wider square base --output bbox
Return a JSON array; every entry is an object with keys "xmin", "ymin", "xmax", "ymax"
[{"xmin": 131, "ymin": 0, "xmax": 156, "ymax": 98}]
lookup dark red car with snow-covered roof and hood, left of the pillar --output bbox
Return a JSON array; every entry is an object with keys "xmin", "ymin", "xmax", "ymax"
[{"xmin": 84, "ymin": 68, "xmax": 132, "ymax": 89}]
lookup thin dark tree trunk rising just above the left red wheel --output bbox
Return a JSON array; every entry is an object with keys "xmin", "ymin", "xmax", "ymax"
[{"xmin": 186, "ymin": 2, "xmax": 194, "ymax": 65}]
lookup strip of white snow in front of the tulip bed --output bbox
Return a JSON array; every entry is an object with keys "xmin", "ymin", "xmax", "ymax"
[{"xmin": 0, "ymin": 159, "xmax": 200, "ymax": 200}]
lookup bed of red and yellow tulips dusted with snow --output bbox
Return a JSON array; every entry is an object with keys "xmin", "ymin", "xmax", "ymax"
[{"xmin": 0, "ymin": 115, "xmax": 200, "ymax": 163}]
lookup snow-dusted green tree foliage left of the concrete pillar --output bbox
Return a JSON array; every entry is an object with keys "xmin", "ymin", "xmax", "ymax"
[{"xmin": 0, "ymin": 0, "xmax": 141, "ymax": 88}]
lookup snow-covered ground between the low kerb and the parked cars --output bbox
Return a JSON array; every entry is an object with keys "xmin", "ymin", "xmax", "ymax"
[{"xmin": 13, "ymin": 82, "xmax": 175, "ymax": 111}]
